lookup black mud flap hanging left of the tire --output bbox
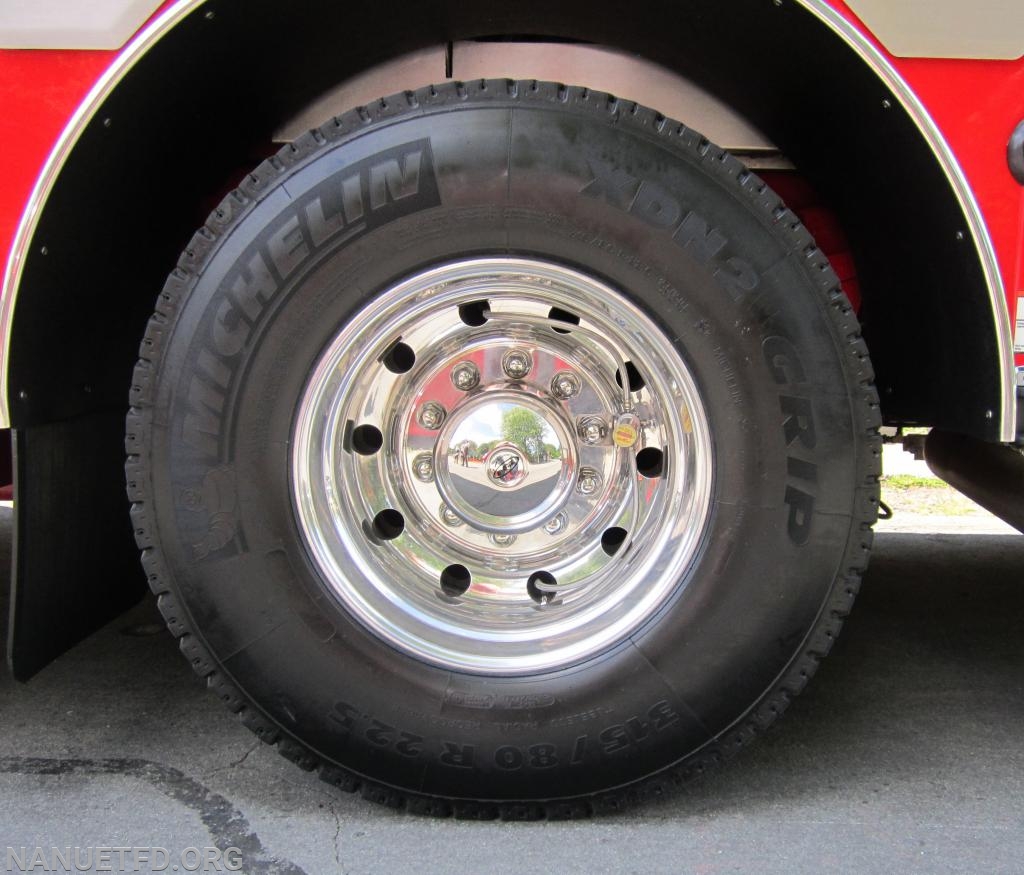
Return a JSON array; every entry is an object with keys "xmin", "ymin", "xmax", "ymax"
[{"xmin": 7, "ymin": 411, "xmax": 146, "ymax": 680}]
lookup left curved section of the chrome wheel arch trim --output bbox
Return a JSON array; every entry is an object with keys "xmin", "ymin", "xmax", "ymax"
[{"xmin": 0, "ymin": 0, "xmax": 205, "ymax": 428}]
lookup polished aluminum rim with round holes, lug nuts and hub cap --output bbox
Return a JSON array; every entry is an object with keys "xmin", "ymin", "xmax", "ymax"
[{"xmin": 292, "ymin": 258, "xmax": 714, "ymax": 674}]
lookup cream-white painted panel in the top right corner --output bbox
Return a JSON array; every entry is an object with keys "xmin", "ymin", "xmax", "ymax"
[{"xmin": 847, "ymin": 0, "xmax": 1024, "ymax": 60}]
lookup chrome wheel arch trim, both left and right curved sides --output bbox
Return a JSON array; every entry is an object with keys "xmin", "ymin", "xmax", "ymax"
[{"xmin": 0, "ymin": 0, "xmax": 1017, "ymax": 442}]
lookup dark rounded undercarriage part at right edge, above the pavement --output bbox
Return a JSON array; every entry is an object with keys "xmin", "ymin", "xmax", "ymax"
[{"xmin": 925, "ymin": 429, "xmax": 1024, "ymax": 532}]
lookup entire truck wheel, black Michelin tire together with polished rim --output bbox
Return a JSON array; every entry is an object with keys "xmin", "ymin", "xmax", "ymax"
[{"xmin": 127, "ymin": 81, "xmax": 880, "ymax": 819}]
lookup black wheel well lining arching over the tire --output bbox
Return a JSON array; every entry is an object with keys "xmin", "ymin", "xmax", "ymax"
[{"xmin": 0, "ymin": 0, "xmax": 1004, "ymax": 680}]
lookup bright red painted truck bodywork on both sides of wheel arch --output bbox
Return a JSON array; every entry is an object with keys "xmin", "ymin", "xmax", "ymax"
[{"xmin": 0, "ymin": 0, "xmax": 1024, "ymax": 364}]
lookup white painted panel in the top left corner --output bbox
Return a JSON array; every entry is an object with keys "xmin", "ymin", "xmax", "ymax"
[{"xmin": 0, "ymin": 0, "xmax": 160, "ymax": 49}]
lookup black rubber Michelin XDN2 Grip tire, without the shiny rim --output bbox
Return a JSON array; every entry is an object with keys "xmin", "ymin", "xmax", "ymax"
[{"xmin": 127, "ymin": 80, "xmax": 881, "ymax": 819}]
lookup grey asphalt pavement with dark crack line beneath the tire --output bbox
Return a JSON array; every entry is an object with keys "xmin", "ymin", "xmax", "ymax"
[{"xmin": 0, "ymin": 511, "xmax": 1024, "ymax": 875}]
